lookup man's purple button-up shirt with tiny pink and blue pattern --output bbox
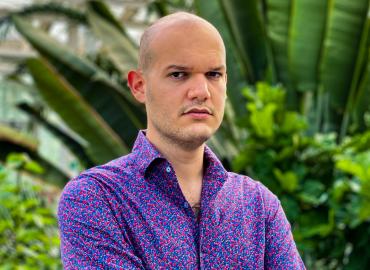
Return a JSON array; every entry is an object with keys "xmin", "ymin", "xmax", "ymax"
[{"xmin": 58, "ymin": 132, "xmax": 305, "ymax": 269}]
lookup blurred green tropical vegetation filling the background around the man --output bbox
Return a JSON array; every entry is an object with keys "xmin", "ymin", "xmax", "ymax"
[{"xmin": 0, "ymin": 0, "xmax": 370, "ymax": 269}]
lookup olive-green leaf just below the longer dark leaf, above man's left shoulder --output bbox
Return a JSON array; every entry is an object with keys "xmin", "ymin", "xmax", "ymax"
[{"xmin": 27, "ymin": 59, "xmax": 128, "ymax": 163}]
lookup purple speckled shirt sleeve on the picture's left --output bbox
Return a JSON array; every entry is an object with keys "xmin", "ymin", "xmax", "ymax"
[{"xmin": 58, "ymin": 176, "xmax": 144, "ymax": 269}]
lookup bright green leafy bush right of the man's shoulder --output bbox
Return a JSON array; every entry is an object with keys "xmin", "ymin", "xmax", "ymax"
[{"xmin": 233, "ymin": 83, "xmax": 370, "ymax": 269}]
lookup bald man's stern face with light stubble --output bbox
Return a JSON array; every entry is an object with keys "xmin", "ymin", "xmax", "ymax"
[{"xmin": 144, "ymin": 24, "xmax": 226, "ymax": 148}]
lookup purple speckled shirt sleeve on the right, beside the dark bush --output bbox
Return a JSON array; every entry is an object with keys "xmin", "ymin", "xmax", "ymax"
[{"xmin": 262, "ymin": 187, "xmax": 306, "ymax": 270}]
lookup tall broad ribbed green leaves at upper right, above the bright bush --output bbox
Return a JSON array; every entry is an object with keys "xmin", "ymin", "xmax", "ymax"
[{"xmin": 198, "ymin": 0, "xmax": 370, "ymax": 135}]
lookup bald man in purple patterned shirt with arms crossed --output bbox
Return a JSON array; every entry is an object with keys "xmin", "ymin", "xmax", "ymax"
[{"xmin": 58, "ymin": 12, "xmax": 304, "ymax": 269}]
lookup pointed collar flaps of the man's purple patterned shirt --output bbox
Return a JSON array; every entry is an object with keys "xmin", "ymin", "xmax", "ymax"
[{"xmin": 132, "ymin": 130, "xmax": 227, "ymax": 183}]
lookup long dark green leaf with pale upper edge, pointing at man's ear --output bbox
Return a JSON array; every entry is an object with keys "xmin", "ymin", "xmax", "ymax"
[{"xmin": 13, "ymin": 17, "xmax": 145, "ymax": 149}]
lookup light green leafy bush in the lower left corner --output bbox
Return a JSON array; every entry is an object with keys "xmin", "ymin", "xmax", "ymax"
[{"xmin": 0, "ymin": 154, "xmax": 62, "ymax": 269}]
